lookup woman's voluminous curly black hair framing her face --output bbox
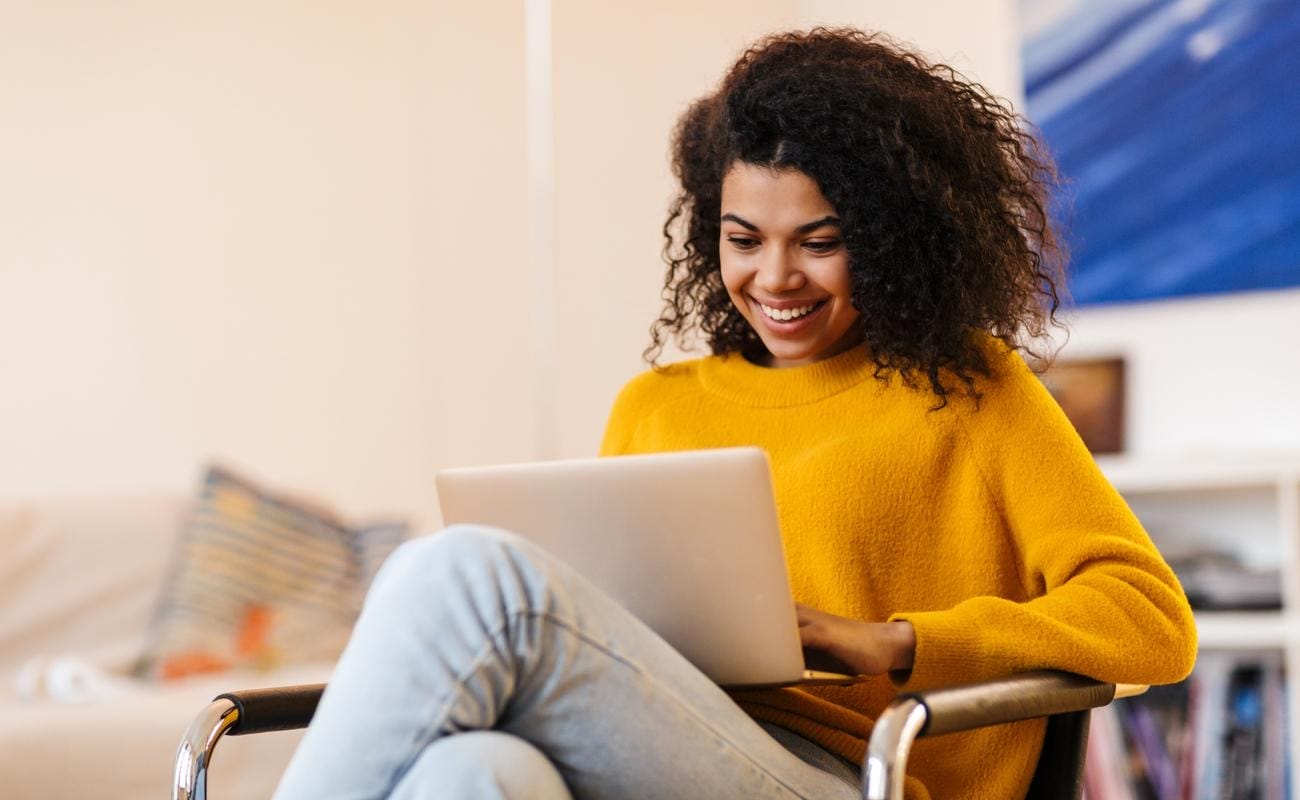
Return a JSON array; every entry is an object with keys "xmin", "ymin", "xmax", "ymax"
[{"xmin": 645, "ymin": 29, "xmax": 1065, "ymax": 407}]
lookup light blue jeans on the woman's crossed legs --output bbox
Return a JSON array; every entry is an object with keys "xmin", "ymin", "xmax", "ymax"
[{"xmin": 276, "ymin": 526, "xmax": 862, "ymax": 800}]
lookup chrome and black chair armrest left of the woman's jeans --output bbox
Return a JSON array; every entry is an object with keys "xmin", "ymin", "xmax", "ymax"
[{"xmin": 172, "ymin": 683, "xmax": 325, "ymax": 800}]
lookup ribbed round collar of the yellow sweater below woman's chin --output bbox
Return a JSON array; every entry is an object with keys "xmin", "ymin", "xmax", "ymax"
[{"xmin": 699, "ymin": 346, "xmax": 875, "ymax": 408}]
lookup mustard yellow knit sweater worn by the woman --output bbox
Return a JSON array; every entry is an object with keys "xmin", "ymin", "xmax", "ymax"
[{"xmin": 602, "ymin": 342, "xmax": 1196, "ymax": 800}]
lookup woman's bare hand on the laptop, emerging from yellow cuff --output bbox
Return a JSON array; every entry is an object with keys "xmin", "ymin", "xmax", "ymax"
[{"xmin": 794, "ymin": 604, "xmax": 917, "ymax": 675}]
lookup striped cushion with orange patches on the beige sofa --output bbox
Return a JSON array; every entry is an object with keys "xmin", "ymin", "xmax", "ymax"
[{"xmin": 139, "ymin": 467, "xmax": 406, "ymax": 678}]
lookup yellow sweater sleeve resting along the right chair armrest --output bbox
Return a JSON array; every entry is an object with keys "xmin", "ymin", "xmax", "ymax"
[{"xmin": 892, "ymin": 354, "xmax": 1196, "ymax": 688}]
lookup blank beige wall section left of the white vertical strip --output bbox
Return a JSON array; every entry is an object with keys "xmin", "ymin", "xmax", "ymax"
[{"xmin": 0, "ymin": 0, "xmax": 537, "ymax": 518}]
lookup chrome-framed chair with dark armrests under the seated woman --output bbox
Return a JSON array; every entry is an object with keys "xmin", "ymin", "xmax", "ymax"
[{"xmin": 172, "ymin": 671, "xmax": 1147, "ymax": 800}]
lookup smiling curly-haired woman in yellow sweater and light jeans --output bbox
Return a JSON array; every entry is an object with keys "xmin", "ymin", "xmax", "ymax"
[{"xmin": 277, "ymin": 30, "xmax": 1195, "ymax": 799}]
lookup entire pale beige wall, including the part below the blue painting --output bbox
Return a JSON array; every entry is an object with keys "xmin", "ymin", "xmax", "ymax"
[{"xmin": 0, "ymin": 0, "xmax": 1300, "ymax": 520}]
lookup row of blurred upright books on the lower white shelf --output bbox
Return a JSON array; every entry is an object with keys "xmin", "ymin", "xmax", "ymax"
[{"xmin": 1084, "ymin": 652, "xmax": 1288, "ymax": 800}]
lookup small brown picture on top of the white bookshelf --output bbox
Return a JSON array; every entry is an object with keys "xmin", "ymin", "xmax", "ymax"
[{"xmin": 1040, "ymin": 356, "xmax": 1125, "ymax": 454}]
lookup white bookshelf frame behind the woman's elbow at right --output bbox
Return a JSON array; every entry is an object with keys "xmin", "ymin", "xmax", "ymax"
[{"xmin": 1097, "ymin": 457, "xmax": 1300, "ymax": 797}]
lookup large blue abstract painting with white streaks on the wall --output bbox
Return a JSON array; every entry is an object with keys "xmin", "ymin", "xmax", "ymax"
[{"xmin": 1021, "ymin": 0, "xmax": 1300, "ymax": 306}]
